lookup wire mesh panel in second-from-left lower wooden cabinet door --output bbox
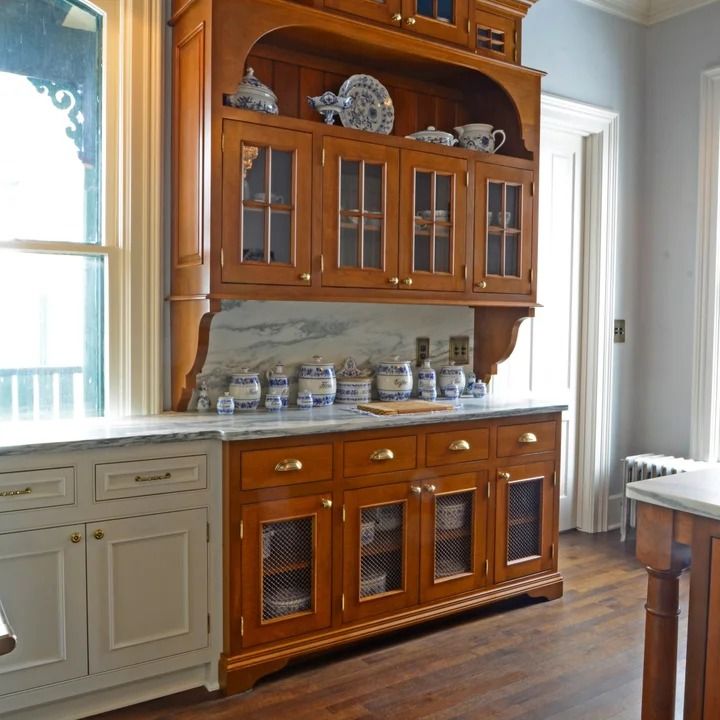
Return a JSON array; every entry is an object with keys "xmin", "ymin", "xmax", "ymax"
[{"xmin": 359, "ymin": 503, "xmax": 405, "ymax": 599}]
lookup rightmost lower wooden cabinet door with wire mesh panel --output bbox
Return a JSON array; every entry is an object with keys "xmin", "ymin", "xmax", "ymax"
[{"xmin": 495, "ymin": 462, "xmax": 556, "ymax": 582}]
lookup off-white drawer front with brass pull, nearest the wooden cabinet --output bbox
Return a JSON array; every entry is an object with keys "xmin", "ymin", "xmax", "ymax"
[{"xmin": 95, "ymin": 455, "xmax": 207, "ymax": 500}]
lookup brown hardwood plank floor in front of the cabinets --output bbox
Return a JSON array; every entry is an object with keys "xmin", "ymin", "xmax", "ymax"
[{"xmin": 90, "ymin": 532, "xmax": 688, "ymax": 720}]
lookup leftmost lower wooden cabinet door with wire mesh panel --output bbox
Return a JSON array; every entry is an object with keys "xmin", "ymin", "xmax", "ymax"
[{"xmin": 241, "ymin": 495, "xmax": 332, "ymax": 647}]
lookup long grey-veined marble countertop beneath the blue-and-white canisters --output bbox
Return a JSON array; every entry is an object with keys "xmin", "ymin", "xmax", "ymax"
[{"xmin": 0, "ymin": 396, "xmax": 567, "ymax": 456}]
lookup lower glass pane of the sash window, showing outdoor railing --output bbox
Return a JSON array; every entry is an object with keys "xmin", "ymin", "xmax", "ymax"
[{"xmin": 0, "ymin": 250, "xmax": 105, "ymax": 420}]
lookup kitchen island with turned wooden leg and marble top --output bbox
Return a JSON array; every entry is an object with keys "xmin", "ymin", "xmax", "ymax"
[{"xmin": 626, "ymin": 469, "xmax": 720, "ymax": 720}]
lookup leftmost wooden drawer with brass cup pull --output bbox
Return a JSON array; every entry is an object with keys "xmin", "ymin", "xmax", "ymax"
[{"xmin": 241, "ymin": 443, "xmax": 332, "ymax": 490}]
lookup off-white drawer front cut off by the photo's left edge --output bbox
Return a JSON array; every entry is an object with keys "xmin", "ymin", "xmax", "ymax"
[{"xmin": 0, "ymin": 467, "xmax": 75, "ymax": 512}]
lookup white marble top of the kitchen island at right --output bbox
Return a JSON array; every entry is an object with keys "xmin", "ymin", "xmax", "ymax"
[{"xmin": 625, "ymin": 468, "xmax": 720, "ymax": 520}]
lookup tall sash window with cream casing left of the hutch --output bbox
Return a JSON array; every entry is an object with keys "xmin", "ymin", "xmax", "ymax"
[{"xmin": 0, "ymin": 0, "xmax": 163, "ymax": 420}]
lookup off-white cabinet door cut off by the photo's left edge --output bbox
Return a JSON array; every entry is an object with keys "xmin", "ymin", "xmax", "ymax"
[{"xmin": 0, "ymin": 525, "xmax": 88, "ymax": 694}]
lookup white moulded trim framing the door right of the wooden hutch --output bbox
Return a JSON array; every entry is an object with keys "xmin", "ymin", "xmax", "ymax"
[{"xmin": 541, "ymin": 94, "xmax": 619, "ymax": 532}]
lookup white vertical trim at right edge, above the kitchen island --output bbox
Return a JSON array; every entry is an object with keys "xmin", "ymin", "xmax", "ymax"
[{"xmin": 690, "ymin": 68, "xmax": 720, "ymax": 461}]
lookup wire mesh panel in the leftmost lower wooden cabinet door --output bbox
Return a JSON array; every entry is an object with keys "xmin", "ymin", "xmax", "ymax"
[{"xmin": 261, "ymin": 517, "xmax": 314, "ymax": 620}]
